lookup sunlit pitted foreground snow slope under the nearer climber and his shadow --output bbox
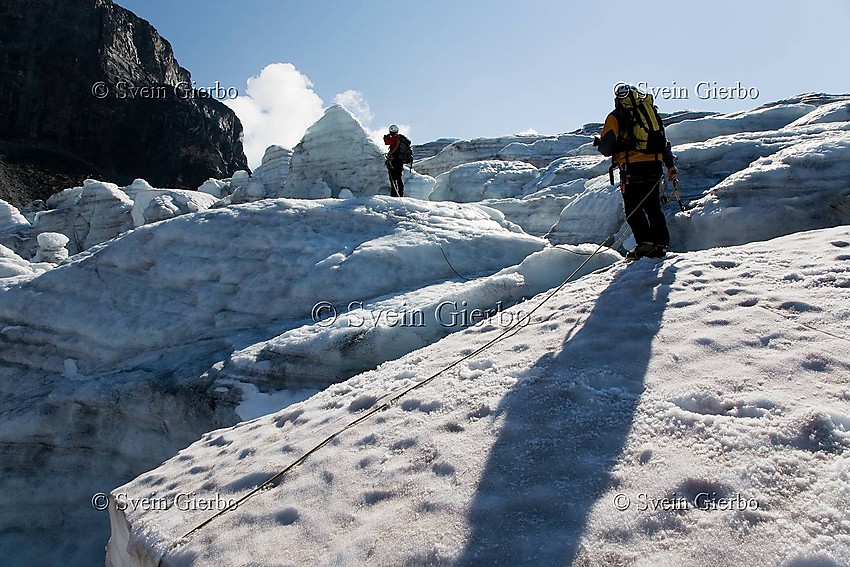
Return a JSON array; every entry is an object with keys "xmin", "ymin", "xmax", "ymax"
[{"xmin": 107, "ymin": 226, "xmax": 850, "ymax": 566}]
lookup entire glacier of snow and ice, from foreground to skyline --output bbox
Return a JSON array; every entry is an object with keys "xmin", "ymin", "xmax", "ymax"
[{"xmin": 0, "ymin": 94, "xmax": 850, "ymax": 567}]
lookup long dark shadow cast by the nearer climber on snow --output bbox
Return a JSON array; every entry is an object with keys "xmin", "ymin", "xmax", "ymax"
[{"xmin": 456, "ymin": 260, "xmax": 676, "ymax": 566}]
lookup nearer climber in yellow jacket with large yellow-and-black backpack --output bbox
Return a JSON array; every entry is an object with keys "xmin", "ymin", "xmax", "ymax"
[{"xmin": 594, "ymin": 83, "xmax": 679, "ymax": 258}]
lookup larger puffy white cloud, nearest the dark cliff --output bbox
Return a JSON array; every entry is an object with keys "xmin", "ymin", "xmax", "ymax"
[{"xmin": 224, "ymin": 63, "xmax": 324, "ymax": 169}]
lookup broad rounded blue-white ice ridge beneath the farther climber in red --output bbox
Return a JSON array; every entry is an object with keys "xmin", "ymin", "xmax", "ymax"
[{"xmin": 0, "ymin": 197, "xmax": 545, "ymax": 373}]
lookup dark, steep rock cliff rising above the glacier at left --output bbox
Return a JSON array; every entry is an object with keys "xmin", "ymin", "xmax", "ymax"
[{"xmin": 0, "ymin": 0, "xmax": 247, "ymax": 206}]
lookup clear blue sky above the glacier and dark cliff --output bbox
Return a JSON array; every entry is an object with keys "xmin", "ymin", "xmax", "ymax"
[{"xmin": 117, "ymin": 0, "xmax": 850, "ymax": 164}]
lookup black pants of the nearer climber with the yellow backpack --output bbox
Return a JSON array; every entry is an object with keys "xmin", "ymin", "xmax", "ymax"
[{"xmin": 620, "ymin": 161, "xmax": 670, "ymax": 246}]
